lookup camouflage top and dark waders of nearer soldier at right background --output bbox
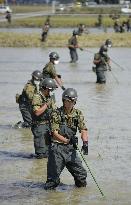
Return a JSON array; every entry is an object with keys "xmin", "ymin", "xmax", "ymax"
[{"xmin": 94, "ymin": 53, "xmax": 110, "ymax": 84}]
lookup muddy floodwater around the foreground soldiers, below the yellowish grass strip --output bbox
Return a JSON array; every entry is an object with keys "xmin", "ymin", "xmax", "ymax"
[{"xmin": 0, "ymin": 48, "xmax": 131, "ymax": 205}]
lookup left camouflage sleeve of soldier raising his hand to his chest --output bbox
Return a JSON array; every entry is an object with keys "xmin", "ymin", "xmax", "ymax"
[{"xmin": 32, "ymin": 94, "xmax": 43, "ymax": 112}]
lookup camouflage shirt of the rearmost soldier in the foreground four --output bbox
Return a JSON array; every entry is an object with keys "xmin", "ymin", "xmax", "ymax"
[{"xmin": 43, "ymin": 62, "xmax": 57, "ymax": 79}]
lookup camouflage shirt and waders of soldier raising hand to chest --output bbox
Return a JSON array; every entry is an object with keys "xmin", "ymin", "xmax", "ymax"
[{"xmin": 31, "ymin": 92, "xmax": 56, "ymax": 156}]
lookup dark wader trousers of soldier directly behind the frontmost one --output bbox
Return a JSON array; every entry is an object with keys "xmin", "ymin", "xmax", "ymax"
[{"xmin": 31, "ymin": 124, "xmax": 51, "ymax": 155}]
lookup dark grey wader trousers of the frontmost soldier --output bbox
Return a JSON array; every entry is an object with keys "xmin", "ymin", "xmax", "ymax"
[{"xmin": 45, "ymin": 143, "xmax": 87, "ymax": 189}]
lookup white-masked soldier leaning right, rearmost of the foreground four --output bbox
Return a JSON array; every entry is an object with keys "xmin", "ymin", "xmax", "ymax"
[{"xmin": 43, "ymin": 52, "xmax": 65, "ymax": 90}]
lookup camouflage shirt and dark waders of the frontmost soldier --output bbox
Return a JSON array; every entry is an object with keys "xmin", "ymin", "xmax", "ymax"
[{"xmin": 45, "ymin": 106, "xmax": 87, "ymax": 189}]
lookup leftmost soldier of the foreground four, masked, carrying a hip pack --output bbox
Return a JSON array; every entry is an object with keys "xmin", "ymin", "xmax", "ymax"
[{"xmin": 15, "ymin": 70, "xmax": 42, "ymax": 128}]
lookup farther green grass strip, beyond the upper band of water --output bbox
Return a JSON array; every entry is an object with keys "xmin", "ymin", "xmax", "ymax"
[{"xmin": 0, "ymin": 15, "xmax": 127, "ymax": 28}]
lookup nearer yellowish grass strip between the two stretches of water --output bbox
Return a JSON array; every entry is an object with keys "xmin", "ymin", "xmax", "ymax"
[{"xmin": 0, "ymin": 33, "xmax": 131, "ymax": 48}]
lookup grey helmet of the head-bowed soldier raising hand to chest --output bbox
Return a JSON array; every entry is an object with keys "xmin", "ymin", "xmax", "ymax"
[{"xmin": 40, "ymin": 78, "xmax": 58, "ymax": 90}]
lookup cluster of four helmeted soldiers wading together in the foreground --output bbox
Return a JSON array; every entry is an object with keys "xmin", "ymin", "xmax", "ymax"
[{"xmin": 15, "ymin": 52, "xmax": 88, "ymax": 190}]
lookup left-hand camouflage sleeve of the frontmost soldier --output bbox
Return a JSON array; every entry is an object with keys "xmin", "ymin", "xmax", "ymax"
[{"xmin": 51, "ymin": 110, "xmax": 61, "ymax": 132}]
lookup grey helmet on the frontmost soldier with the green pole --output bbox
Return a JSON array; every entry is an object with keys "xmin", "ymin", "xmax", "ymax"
[{"xmin": 62, "ymin": 88, "xmax": 78, "ymax": 101}]
